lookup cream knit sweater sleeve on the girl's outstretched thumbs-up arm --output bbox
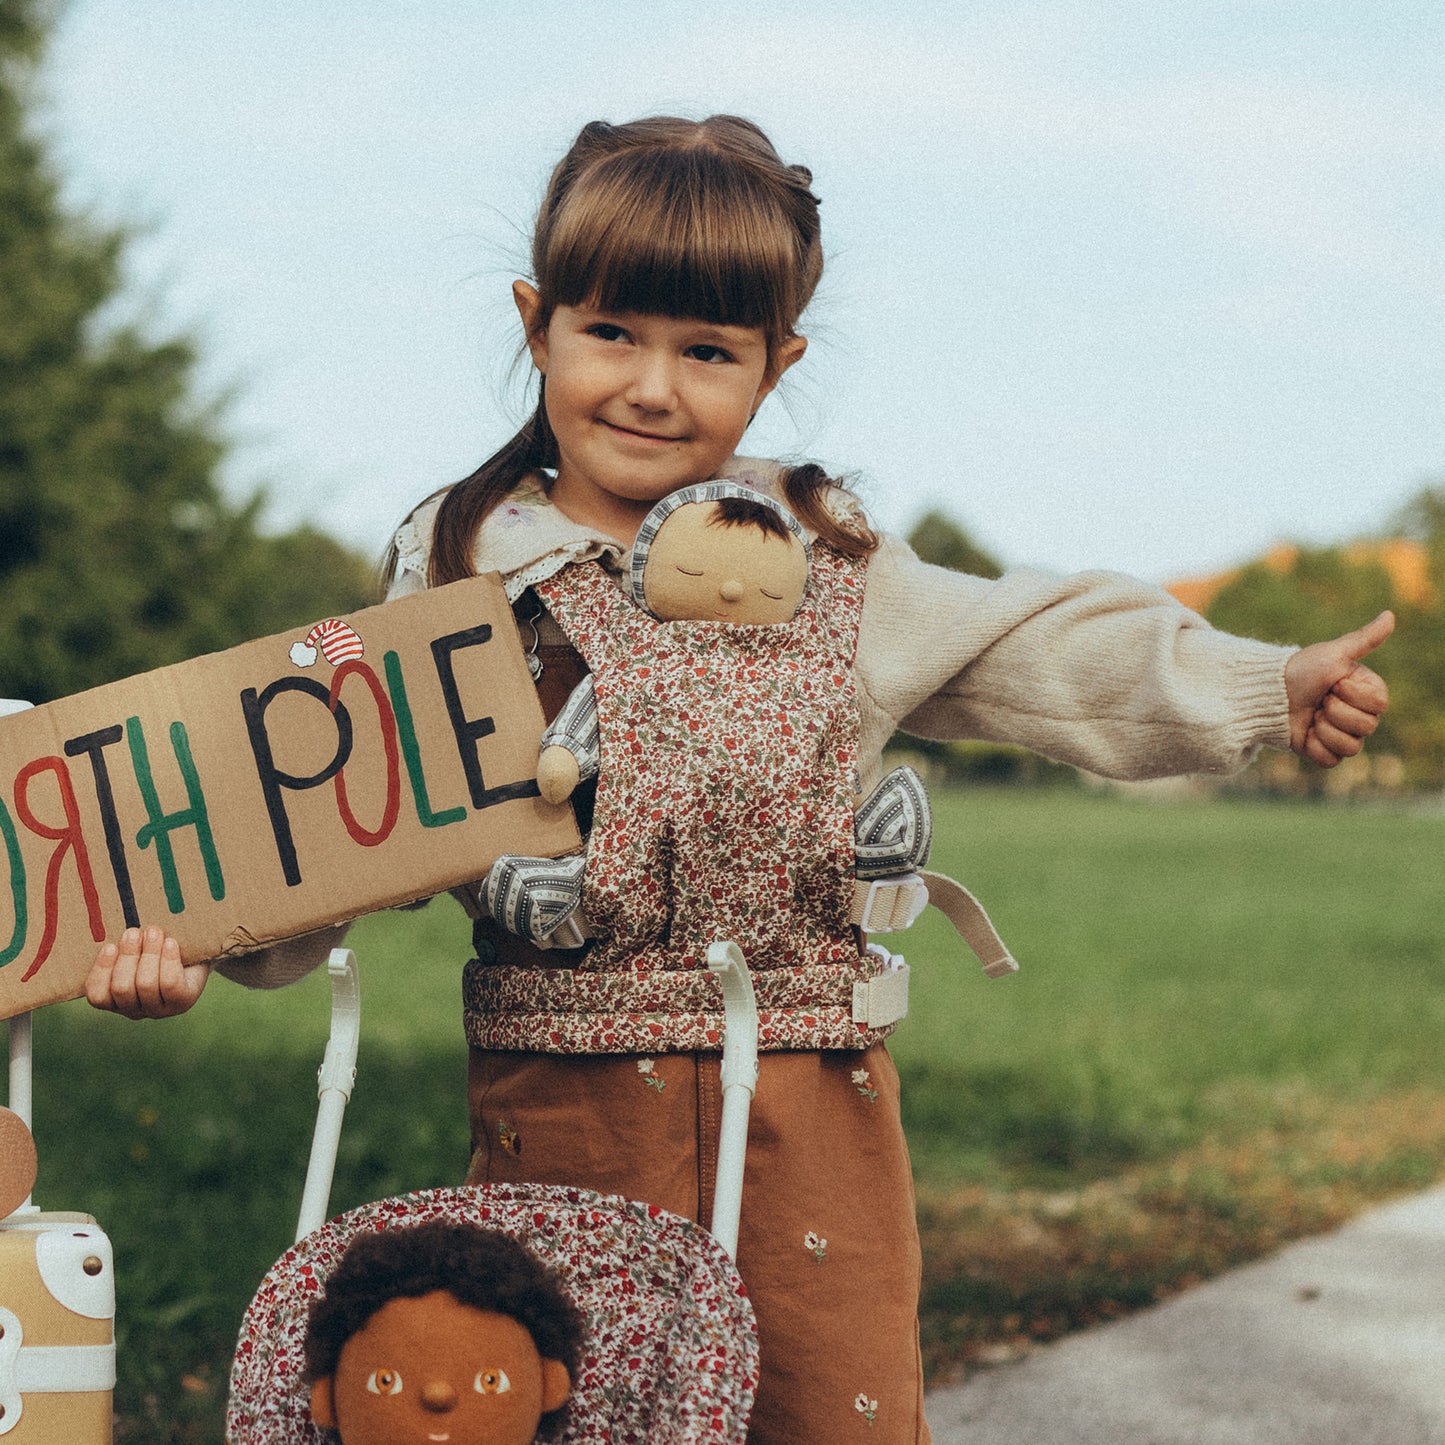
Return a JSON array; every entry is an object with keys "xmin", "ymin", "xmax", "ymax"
[{"xmin": 857, "ymin": 538, "xmax": 1292, "ymax": 779}]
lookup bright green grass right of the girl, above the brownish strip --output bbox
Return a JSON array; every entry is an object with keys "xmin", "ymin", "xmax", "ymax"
[{"xmin": 894, "ymin": 792, "xmax": 1445, "ymax": 1183}]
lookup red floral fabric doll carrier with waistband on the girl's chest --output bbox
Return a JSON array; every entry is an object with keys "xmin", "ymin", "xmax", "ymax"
[{"xmin": 464, "ymin": 545, "xmax": 890, "ymax": 1053}]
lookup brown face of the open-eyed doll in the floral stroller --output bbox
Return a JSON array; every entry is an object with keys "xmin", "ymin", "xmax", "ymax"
[{"xmin": 311, "ymin": 1290, "xmax": 569, "ymax": 1445}]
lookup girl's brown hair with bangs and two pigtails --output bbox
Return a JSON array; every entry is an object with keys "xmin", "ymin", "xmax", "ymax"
[{"xmin": 386, "ymin": 116, "xmax": 877, "ymax": 587}]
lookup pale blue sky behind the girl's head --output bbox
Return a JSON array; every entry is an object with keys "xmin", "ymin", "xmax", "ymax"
[{"xmin": 43, "ymin": 0, "xmax": 1445, "ymax": 579}]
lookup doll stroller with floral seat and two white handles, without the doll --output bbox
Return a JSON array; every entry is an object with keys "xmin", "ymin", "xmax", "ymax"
[{"xmin": 225, "ymin": 944, "xmax": 759, "ymax": 1445}]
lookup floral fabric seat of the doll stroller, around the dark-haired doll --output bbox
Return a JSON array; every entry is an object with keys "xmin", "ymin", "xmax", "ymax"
[{"xmin": 225, "ymin": 1185, "xmax": 757, "ymax": 1445}]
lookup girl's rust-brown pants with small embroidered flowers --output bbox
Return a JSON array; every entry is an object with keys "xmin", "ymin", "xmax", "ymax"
[{"xmin": 467, "ymin": 1043, "xmax": 929, "ymax": 1445}]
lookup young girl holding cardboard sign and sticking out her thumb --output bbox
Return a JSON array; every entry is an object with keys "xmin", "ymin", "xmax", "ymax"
[{"xmin": 90, "ymin": 116, "xmax": 1392, "ymax": 1445}]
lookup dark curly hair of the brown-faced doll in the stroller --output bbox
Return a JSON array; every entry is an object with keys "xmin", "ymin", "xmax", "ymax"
[{"xmin": 305, "ymin": 1220, "xmax": 587, "ymax": 1439}]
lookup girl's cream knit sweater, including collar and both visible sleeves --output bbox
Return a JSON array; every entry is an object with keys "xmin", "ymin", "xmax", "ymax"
[{"xmin": 218, "ymin": 460, "xmax": 1292, "ymax": 987}]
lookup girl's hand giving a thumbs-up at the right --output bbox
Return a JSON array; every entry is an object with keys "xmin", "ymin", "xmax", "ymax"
[{"xmin": 1285, "ymin": 613, "xmax": 1394, "ymax": 767}]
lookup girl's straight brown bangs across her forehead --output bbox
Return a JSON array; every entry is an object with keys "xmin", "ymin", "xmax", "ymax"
[{"xmin": 539, "ymin": 146, "xmax": 803, "ymax": 344}]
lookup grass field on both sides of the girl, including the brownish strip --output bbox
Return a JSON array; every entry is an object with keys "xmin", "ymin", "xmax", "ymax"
[{"xmin": 22, "ymin": 790, "xmax": 1445, "ymax": 1445}]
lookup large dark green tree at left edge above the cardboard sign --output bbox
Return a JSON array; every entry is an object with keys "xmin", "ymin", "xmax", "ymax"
[{"xmin": 0, "ymin": 0, "xmax": 373, "ymax": 702}]
